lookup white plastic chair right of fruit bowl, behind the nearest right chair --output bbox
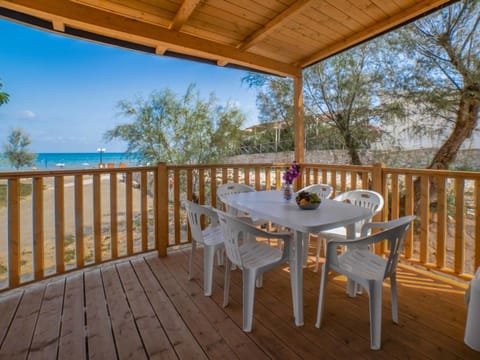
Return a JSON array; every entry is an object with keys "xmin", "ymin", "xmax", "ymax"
[{"xmin": 314, "ymin": 190, "xmax": 384, "ymax": 271}]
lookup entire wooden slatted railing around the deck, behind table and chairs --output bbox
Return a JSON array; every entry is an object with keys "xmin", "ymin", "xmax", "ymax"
[{"xmin": 0, "ymin": 163, "xmax": 480, "ymax": 290}]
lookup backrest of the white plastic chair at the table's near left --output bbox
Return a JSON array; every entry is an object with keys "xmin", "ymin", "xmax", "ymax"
[{"xmin": 217, "ymin": 211, "xmax": 251, "ymax": 268}]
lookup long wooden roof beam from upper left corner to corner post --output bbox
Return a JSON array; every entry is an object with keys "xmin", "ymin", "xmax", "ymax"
[{"xmin": 0, "ymin": 0, "xmax": 301, "ymax": 77}]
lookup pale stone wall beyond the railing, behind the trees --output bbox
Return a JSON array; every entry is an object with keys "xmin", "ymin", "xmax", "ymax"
[{"xmin": 225, "ymin": 149, "xmax": 480, "ymax": 170}]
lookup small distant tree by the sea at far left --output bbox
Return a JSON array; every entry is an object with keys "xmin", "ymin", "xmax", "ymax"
[{"xmin": 3, "ymin": 129, "xmax": 37, "ymax": 170}]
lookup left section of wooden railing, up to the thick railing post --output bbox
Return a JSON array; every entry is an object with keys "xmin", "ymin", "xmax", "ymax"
[{"xmin": 0, "ymin": 167, "xmax": 158, "ymax": 289}]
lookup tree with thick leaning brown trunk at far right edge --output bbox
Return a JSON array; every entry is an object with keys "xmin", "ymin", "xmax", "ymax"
[{"xmin": 398, "ymin": 0, "xmax": 480, "ymax": 169}]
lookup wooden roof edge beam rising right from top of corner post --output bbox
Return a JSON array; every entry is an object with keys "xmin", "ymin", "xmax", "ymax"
[{"xmin": 297, "ymin": 0, "xmax": 458, "ymax": 69}]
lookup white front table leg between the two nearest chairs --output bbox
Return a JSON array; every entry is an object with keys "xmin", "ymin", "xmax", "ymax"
[{"xmin": 290, "ymin": 231, "xmax": 303, "ymax": 326}]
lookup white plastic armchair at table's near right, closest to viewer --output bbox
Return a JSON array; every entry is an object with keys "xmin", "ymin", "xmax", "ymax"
[{"xmin": 315, "ymin": 216, "xmax": 415, "ymax": 350}]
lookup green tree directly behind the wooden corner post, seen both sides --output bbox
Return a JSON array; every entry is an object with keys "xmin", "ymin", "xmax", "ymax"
[{"xmin": 244, "ymin": 40, "xmax": 401, "ymax": 165}]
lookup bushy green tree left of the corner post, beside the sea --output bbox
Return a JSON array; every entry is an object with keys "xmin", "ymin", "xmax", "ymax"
[{"xmin": 104, "ymin": 85, "xmax": 245, "ymax": 164}]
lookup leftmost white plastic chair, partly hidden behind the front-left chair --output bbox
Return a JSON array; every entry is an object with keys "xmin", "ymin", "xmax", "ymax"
[{"xmin": 184, "ymin": 200, "xmax": 225, "ymax": 296}]
